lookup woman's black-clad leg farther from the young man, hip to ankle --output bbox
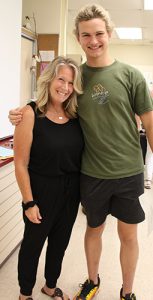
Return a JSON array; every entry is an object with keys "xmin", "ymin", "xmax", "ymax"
[{"xmin": 18, "ymin": 174, "xmax": 55, "ymax": 295}]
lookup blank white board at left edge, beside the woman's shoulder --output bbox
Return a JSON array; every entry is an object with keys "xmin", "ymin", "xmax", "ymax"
[{"xmin": 0, "ymin": 0, "xmax": 22, "ymax": 138}]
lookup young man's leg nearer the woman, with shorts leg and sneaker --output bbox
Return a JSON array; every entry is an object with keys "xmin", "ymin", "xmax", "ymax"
[{"xmin": 73, "ymin": 174, "xmax": 116, "ymax": 300}]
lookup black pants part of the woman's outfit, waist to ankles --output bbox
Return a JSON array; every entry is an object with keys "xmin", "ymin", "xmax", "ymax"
[{"xmin": 18, "ymin": 174, "xmax": 80, "ymax": 295}]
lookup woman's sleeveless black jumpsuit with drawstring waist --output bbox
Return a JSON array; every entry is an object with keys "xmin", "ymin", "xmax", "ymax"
[{"xmin": 18, "ymin": 102, "xmax": 84, "ymax": 295}]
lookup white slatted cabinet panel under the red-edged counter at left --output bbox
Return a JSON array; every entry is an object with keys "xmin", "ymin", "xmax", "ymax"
[{"xmin": 0, "ymin": 162, "xmax": 24, "ymax": 267}]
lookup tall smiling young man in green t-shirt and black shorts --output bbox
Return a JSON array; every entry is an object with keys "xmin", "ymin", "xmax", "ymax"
[{"xmin": 10, "ymin": 5, "xmax": 153, "ymax": 300}]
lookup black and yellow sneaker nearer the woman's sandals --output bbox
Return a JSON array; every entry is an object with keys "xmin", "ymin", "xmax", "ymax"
[{"xmin": 73, "ymin": 275, "xmax": 100, "ymax": 300}]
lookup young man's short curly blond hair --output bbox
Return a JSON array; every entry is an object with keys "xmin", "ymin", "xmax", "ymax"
[{"xmin": 74, "ymin": 4, "xmax": 114, "ymax": 38}]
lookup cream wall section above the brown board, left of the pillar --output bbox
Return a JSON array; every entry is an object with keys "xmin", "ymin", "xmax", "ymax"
[{"xmin": 22, "ymin": 0, "xmax": 61, "ymax": 33}]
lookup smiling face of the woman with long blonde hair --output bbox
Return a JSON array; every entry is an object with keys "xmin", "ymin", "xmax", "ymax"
[{"xmin": 49, "ymin": 65, "xmax": 74, "ymax": 104}]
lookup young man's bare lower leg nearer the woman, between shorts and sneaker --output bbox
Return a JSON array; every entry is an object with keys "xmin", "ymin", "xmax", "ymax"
[{"xmin": 85, "ymin": 224, "xmax": 105, "ymax": 284}]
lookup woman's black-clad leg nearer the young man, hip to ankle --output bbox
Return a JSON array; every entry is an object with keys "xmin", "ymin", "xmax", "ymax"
[{"xmin": 45, "ymin": 178, "xmax": 79, "ymax": 288}]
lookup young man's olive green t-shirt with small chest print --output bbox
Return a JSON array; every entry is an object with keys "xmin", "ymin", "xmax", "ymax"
[{"xmin": 78, "ymin": 61, "xmax": 153, "ymax": 179}]
